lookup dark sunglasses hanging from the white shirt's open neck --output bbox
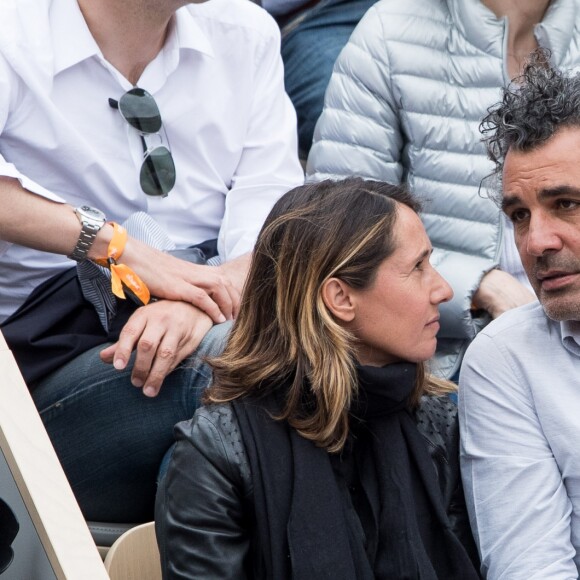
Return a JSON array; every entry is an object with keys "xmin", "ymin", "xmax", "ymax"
[{"xmin": 109, "ymin": 87, "xmax": 175, "ymax": 197}]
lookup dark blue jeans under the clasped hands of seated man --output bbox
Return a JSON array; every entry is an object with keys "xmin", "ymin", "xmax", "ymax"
[{"xmin": 32, "ymin": 323, "xmax": 231, "ymax": 523}]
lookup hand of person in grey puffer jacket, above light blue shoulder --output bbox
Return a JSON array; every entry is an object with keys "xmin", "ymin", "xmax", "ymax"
[{"xmin": 473, "ymin": 270, "xmax": 536, "ymax": 318}]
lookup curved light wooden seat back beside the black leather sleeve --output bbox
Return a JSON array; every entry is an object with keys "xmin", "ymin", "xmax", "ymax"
[{"xmin": 105, "ymin": 522, "xmax": 161, "ymax": 580}]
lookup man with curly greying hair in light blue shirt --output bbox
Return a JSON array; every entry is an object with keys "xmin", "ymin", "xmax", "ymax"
[{"xmin": 459, "ymin": 53, "xmax": 580, "ymax": 580}]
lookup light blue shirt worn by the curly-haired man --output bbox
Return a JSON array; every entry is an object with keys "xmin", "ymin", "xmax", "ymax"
[{"xmin": 459, "ymin": 302, "xmax": 580, "ymax": 580}]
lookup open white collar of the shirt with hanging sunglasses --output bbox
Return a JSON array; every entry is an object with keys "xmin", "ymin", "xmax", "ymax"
[{"xmin": 49, "ymin": 0, "xmax": 214, "ymax": 75}]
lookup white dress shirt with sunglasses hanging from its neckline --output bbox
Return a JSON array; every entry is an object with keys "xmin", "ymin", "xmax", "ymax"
[{"xmin": 0, "ymin": 0, "xmax": 303, "ymax": 321}]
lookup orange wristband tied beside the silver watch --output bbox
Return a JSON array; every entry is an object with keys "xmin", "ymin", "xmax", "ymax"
[{"xmin": 95, "ymin": 222, "xmax": 151, "ymax": 305}]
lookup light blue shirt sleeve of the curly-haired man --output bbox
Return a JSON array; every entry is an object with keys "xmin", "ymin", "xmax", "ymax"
[{"xmin": 459, "ymin": 332, "xmax": 578, "ymax": 580}]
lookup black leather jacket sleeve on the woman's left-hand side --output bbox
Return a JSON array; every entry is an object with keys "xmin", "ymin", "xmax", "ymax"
[{"xmin": 155, "ymin": 405, "xmax": 256, "ymax": 580}]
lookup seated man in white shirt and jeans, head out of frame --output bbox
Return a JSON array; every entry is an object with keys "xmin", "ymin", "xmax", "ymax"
[{"xmin": 0, "ymin": 0, "xmax": 303, "ymax": 521}]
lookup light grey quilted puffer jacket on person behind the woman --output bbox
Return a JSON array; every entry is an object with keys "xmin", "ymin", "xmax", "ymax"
[{"xmin": 307, "ymin": 0, "xmax": 580, "ymax": 376}]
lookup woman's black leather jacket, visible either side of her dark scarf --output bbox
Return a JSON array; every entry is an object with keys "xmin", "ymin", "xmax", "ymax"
[{"xmin": 155, "ymin": 397, "xmax": 478, "ymax": 580}]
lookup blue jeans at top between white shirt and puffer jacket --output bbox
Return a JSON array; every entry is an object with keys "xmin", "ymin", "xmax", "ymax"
[{"xmin": 279, "ymin": 0, "xmax": 376, "ymax": 159}]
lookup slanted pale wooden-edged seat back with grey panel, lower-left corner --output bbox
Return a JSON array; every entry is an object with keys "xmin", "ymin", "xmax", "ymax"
[{"xmin": 0, "ymin": 332, "xmax": 108, "ymax": 580}]
